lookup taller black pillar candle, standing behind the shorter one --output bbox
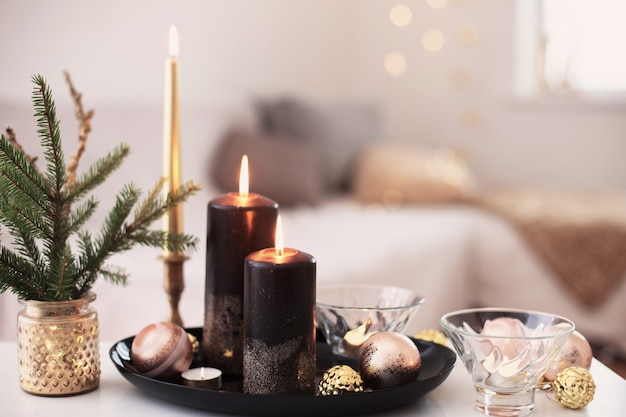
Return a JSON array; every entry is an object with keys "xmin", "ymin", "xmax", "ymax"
[{"xmin": 202, "ymin": 192, "xmax": 278, "ymax": 375}]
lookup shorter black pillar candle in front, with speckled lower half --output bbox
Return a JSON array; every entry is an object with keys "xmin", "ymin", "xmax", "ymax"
[{"xmin": 243, "ymin": 248, "xmax": 316, "ymax": 395}]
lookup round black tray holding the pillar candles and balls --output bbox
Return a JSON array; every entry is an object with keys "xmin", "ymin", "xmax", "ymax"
[{"xmin": 109, "ymin": 328, "xmax": 456, "ymax": 417}]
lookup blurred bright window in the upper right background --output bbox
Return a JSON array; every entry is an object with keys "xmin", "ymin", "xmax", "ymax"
[{"xmin": 517, "ymin": 0, "xmax": 626, "ymax": 93}]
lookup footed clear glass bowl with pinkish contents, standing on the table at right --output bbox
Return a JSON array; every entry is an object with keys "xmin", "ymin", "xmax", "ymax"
[{"xmin": 441, "ymin": 308, "xmax": 574, "ymax": 416}]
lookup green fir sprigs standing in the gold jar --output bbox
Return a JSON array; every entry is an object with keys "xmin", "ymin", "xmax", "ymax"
[{"xmin": 0, "ymin": 75, "xmax": 199, "ymax": 301}]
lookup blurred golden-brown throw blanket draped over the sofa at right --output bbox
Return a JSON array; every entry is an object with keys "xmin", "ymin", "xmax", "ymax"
[{"xmin": 476, "ymin": 189, "xmax": 626, "ymax": 308}]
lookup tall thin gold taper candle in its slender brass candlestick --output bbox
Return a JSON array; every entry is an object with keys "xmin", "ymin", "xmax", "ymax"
[{"xmin": 163, "ymin": 25, "xmax": 187, "ymax": 326}]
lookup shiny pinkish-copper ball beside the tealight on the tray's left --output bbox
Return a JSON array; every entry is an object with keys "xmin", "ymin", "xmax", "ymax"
[{"xmin": 130, "ymin": 322, "xmax": 193, "ymax": 380}]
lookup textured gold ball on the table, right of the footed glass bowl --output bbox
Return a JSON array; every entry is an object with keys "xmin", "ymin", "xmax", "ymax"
[{"xmin": 552, "ymin": 366, "xmax": 596, "ymax": 409}]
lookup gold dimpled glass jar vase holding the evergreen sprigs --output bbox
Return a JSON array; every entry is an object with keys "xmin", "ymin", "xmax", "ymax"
[{"xmin": 17, "ymin": 293, "xmax": 100, "ymax": 396}]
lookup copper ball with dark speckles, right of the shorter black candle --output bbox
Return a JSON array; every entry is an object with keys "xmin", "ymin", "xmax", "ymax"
[{"xmin": 359, "ymin": 332, "xmax": 422, "ymax": 389}]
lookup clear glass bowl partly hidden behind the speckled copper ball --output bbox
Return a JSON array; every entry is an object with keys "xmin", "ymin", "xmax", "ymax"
[{"xmin": 316, "ymin": 284, "xmax": 424, "ymax": 358}]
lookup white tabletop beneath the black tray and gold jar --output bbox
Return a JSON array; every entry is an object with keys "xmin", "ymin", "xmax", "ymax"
[{"xmin": 0, "ymin": 342, "xmax": 626, "ymax": 417}]
